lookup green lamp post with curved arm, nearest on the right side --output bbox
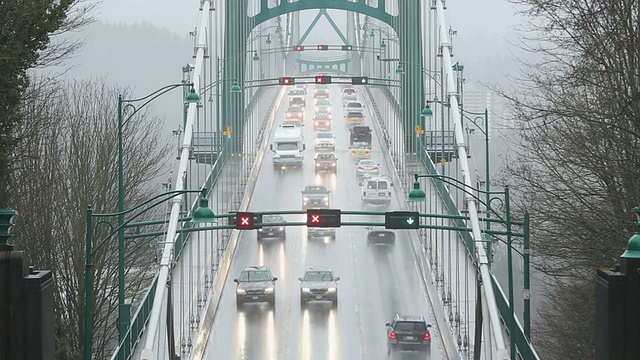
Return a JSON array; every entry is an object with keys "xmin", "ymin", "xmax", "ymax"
[{"xmin": 407, "ymin": 174, "xmax": 530, "ymax": 359}]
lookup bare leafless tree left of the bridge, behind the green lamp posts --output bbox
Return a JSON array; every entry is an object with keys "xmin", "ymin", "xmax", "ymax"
[{"xmin": 11, "ymin": 80, "xmax": 168, "ymax": 359}]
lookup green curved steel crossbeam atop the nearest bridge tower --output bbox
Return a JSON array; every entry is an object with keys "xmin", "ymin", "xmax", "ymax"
[{"xmin": 251, "ymin": 0, "xmax": 392, "ymax": 25}]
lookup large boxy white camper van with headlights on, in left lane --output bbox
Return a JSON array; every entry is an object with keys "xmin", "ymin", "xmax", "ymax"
[{"xmin": 269, "ymin": 125, "xmax": 306, "ymax": 169}]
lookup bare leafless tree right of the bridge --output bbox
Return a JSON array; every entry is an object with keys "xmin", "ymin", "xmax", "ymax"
[{"xmin": 503, "ymin": 0, "xmax": 640, "ymax": 359}]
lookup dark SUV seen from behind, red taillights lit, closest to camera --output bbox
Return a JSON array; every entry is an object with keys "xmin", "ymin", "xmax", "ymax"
[{"xmin": 385, "ymin": 314, "xmax": 431, "ymax": 352}]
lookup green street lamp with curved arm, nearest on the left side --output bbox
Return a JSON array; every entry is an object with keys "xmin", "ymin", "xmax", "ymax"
[{"xmin": 84, "ymin": 188, "xmax": 215, "ymax": 360}]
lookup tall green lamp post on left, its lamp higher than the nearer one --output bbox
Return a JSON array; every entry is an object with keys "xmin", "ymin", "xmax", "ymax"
[{"xmin": 118, "ymin": 83, "xmax": 200, "ymax": 340}]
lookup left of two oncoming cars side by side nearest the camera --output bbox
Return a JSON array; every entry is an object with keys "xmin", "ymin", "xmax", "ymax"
[{"xmin": 233, "ymin": 266, "xmax": 278, "ymax": 307}]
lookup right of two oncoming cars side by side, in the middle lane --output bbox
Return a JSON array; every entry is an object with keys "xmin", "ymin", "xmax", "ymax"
[{"xmin": 298, "ymin": 266, "xmax": 340, "ymax": 306}]
